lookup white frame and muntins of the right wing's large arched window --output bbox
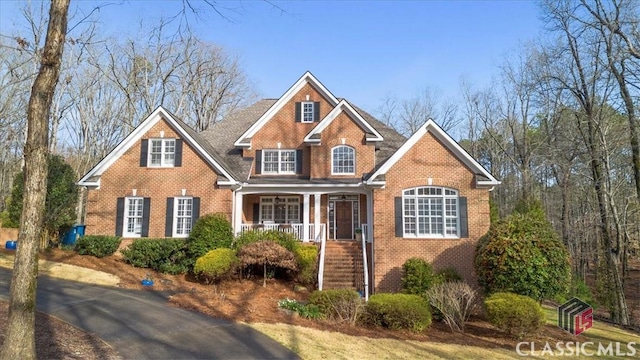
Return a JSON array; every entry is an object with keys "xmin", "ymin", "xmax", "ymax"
[{"xmin": 401, "ymin": 186, "xmax": 460, "ymax": 239}]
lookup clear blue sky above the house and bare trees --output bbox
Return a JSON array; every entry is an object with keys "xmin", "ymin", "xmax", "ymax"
[{"xmin": 0, "ymin": 0, "xmax": 542, "ymax": 112}]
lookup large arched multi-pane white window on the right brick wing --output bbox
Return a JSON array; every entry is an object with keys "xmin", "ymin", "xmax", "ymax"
[{"xmin": 402, "ymin": 186, "xmax": 459, "ymax": 237}]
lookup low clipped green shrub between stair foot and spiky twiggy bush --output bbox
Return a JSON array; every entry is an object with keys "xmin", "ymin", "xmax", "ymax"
[{"xmin": 361, "ymin": 294, "xmax": 431, "ymax": 332}]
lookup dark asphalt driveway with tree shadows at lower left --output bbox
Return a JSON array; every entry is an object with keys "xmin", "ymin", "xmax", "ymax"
[{"xmin": 0, "ymin": 268, "xmax": 298, "ymax": 359}]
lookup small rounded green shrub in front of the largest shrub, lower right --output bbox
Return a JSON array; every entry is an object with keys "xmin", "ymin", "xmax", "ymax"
[{"xmin": 484, "ymin": 293, "xmax": 545, "ymax": 339}]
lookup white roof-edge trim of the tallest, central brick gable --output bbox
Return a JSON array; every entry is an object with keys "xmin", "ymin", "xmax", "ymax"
[{"xmin": 234, "ymin": 71, "xmax": 338, "ymax": 147}]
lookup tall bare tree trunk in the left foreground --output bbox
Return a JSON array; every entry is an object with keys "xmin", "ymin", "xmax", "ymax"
[{"xmin": 0, "ymin": 0, "xmax": 69, "ymax": 360}]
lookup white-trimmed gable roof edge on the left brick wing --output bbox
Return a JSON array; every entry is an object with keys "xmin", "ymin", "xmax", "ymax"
[{"xmin": 78, "ymin": 106, "xmax": 236, "ymax": 186}]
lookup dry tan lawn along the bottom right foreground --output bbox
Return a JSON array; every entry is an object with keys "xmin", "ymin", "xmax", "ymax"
[{"xmin": 249, "ymin": 307, "xmax": 640, "ymax": 360}]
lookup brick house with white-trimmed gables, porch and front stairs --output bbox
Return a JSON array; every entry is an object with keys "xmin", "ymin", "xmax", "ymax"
[{"xmin": 79, "ymin": 72, "xmax": 500, "ymax": 294}]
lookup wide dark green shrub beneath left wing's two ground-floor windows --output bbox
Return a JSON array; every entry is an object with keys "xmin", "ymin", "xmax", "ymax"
[{"xmin": 121, "ymin": 239, "xmax": 191, "ymax": 274}]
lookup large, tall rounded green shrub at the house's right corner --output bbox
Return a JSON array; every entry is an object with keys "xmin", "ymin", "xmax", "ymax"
[{"xmin": 475, "ymin": 201, "xmax": 571, "ymax": 301}]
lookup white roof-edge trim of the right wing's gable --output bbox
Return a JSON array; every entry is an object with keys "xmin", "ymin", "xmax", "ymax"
[{"xmin": 367, "ymin": 119, "xmax": 500, "ymax": 186}]
